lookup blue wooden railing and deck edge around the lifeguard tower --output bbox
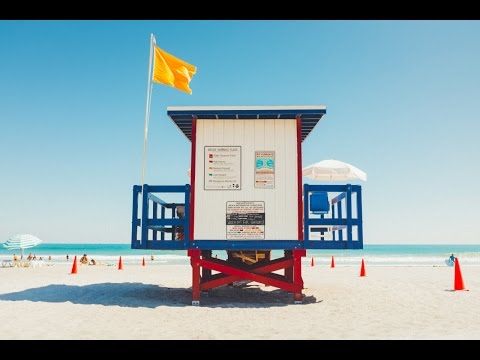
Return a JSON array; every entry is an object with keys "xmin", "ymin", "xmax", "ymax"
[{"xmin": 131, "ymin": 184, "xmax": 363, "ymax": 250}]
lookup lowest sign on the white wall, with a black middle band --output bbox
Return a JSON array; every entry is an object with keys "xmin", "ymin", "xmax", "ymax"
[{"xmin": 226, "ymin": 201, "xmax": 265, "ymax": 240}]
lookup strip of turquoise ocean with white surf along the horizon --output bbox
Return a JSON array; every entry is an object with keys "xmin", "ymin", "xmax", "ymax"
[{"xmin": 0, "ymin": 243, "xmax": 480, "ymax": 266}]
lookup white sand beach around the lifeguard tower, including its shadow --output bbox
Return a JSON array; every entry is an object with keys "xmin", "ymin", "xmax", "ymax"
[{"xmin": 0, "ymin": 264, "xmax": 480, "ymax": 339}]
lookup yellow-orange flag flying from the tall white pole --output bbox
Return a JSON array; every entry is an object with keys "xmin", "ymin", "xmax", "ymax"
[{"xmin": 152, "ymin": 45, "xmax": 197, "ymax": 94}]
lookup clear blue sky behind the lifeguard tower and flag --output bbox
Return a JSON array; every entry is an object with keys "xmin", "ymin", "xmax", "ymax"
[{"xmin": 0, "ymin": 20, "xmax": 480, "ymax": 244}]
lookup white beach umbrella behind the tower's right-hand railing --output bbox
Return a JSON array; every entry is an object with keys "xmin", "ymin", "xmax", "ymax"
[{"xmin": 302, "ymin": 160, "xmax": 367, "ymax": 181}]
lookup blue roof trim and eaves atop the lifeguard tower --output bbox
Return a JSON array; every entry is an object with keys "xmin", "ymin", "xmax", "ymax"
[{"xmin": 167, "ymin": 109, "xmax": 327, "ymax": 141}]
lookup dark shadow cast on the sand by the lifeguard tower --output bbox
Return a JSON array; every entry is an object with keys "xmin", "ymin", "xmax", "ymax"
[{"xmin": 0, "ymin": 283, "xmax": 321, "ymax": 308}]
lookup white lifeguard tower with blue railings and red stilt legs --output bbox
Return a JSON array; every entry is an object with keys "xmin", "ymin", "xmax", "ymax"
[{"xmin": 131, "ymin": 106, "xmax": 363, "ymax": 305}]
